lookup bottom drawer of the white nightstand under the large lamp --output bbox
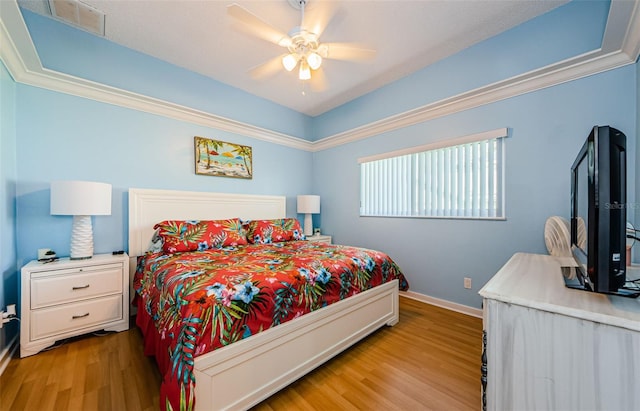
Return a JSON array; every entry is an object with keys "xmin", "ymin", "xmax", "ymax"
[{"xmin": 30, "ymin": 294, "xmax": 122, "ymax": 340}]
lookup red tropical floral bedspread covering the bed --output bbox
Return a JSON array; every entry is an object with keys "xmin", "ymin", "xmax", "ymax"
[{"xmin": 134, "ymin": 241, "xmax": 408, "ymax": 410}]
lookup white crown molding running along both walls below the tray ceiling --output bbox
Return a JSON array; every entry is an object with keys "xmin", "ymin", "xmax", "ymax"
[{"xmin": 0, "ymin": 0, "xmax": 640, "ymax": 151}]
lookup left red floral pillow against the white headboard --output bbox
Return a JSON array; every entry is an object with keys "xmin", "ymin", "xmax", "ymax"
[{"xmin": 153, "ymin": 218, "xmax": 247, "ymax": 253}]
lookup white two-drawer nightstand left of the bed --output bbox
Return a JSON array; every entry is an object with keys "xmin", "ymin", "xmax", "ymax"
[{"xmin": 20, "ymin": 254, "xmax": 129, "ymax": 357}]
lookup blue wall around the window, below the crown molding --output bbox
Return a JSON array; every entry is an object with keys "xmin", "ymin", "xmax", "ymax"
[{"xmin": 313, "ymin": 65, "xmax": 637, "ymax": 308}]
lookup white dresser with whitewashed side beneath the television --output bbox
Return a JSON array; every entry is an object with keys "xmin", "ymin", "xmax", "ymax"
[{"xmin": 480, "ymin": 253, "xmax": 640, "ymax": 411}]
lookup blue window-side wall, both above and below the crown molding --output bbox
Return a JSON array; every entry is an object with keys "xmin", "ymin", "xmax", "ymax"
[{"xmin": 314, "ymin": 1, "xmax": 638, "ymax": 308}]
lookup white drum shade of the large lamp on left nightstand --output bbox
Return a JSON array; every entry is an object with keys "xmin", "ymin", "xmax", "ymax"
[{"xmin": 51, "ymin": 181, "xmax": 111, "ymax": 215}]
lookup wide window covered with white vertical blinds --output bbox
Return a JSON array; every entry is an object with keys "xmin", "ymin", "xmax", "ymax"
[{"xmin": 358, "ymin": 128, "xmax": 508, "ymax": 219}]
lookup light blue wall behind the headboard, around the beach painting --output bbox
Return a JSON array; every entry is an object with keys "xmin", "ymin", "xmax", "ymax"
[{"xmin": 16, "ymin": 85, "xmax": 311, "ymax": 264}]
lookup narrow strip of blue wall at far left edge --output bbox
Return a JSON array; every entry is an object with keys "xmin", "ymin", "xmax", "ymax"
[{"xmin": 0, "ymin": 62, "xmax": 18, "ymax": 344}]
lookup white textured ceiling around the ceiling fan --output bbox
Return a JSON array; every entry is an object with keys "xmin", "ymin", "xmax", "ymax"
[{"xmin": 16, "ymin": 0, "xmax": 566, "ymax": 116}]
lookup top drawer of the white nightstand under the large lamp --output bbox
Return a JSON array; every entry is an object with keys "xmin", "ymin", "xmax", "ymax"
[{"xmin": 31, "ymin": 264, "xmax": 122, "ymax": 309}]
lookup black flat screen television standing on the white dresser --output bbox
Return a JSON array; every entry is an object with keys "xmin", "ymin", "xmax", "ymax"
[{"xmin": 567, "ymin": 126, "xmax": 638, "ymax": 297}]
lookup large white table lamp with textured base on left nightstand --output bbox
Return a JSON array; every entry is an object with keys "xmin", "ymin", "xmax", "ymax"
[{"xmin": 51, "ymin": 181, "xmax": 111, "ymax": 260}]
